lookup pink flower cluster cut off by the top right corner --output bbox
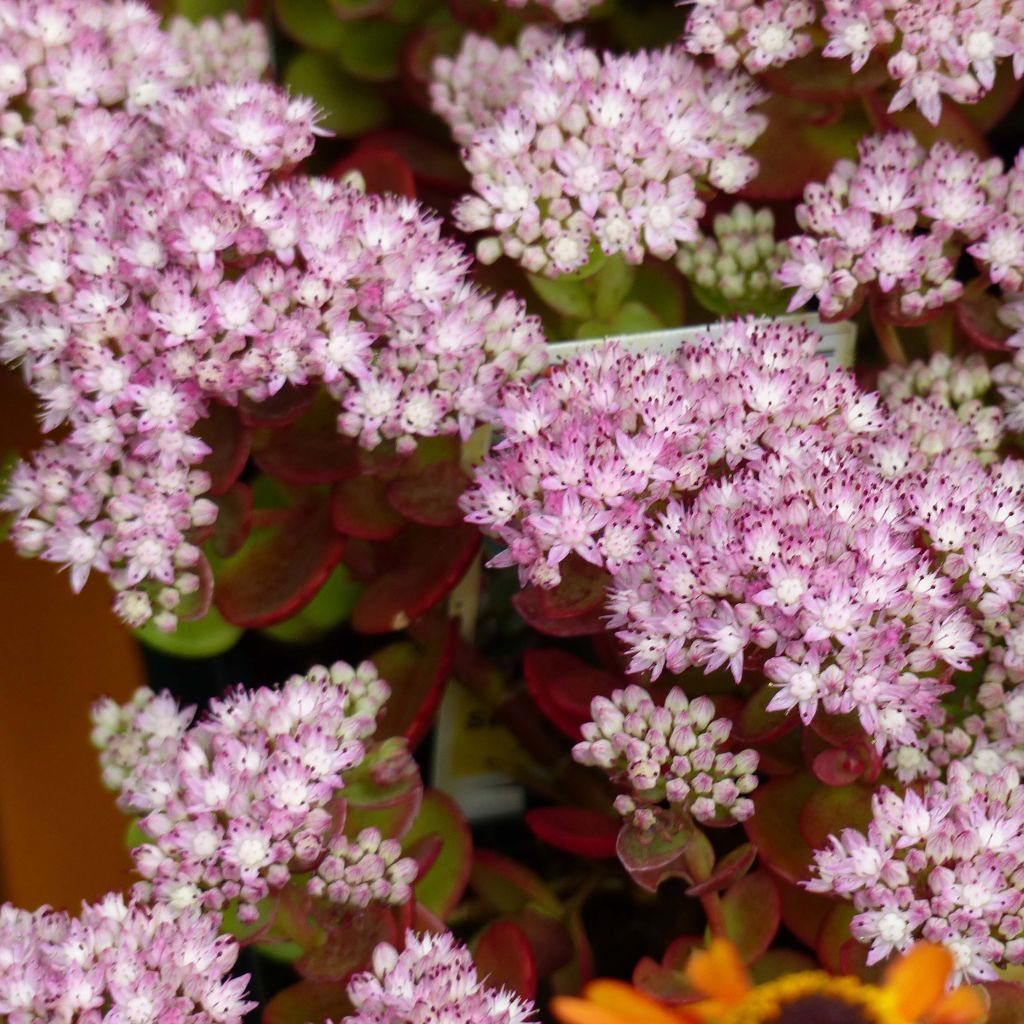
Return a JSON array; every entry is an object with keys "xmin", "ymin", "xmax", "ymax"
[{"xmin": 686, "ymin": 0, "xmax": 1024, "ymax": 124}]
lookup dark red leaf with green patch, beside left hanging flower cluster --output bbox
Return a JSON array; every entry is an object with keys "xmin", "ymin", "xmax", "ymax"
[{"xmin": 216, "ymin": 500, "xmax": 345, "ymax": 629}]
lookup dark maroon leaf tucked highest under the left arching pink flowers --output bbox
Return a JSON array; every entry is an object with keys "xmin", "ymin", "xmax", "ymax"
[{"xmin": 254, "ymin": 391, "xmax": 359, "ymax": 483}]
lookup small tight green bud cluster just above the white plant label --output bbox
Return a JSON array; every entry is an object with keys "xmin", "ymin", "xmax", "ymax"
[{"xmin": 676, "ymin": 203, "xmax": 786, "ymax": 314}]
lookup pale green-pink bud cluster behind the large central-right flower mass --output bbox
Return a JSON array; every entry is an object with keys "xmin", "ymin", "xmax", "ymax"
[{"xmin": 879, "ymin": 352, "xmax": 1004, "ymax": 471}]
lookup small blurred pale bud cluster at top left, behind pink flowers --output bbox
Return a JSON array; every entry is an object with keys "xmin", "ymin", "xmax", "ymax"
[{"xmin": 173, "ymin": 11, "xmax": 270, "ymax": 85}]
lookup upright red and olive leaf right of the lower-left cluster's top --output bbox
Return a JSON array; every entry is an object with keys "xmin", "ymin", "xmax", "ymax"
[{"xmin": 373, "ymin": 622, "xmax": 458, "ymax": 748}]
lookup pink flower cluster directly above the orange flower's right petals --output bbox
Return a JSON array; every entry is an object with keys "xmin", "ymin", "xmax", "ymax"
[{"xmin": 808, "ymin": 762, "xmax": 1024, "ymax": 981}]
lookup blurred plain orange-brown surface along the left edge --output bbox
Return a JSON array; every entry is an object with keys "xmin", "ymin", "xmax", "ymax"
[{"xmin": 0, "ymin": 369, "xmax": 144, "ymax": 909}]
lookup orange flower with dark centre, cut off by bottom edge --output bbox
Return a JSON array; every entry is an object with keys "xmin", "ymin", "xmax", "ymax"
[{"xmin": 552, "ymin": 940, "xmax": 986, "ymax": 1024}]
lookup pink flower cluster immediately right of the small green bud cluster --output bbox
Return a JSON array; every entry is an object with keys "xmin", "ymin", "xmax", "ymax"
[{"xmin": 778, "ymin": 133, "xmax": 1007, "ymax": 317}]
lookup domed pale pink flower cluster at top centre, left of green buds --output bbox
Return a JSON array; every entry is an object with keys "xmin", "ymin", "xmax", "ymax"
[{"xmin": 437, "ymin": 33, "xmax": 765, "ymax": 278}]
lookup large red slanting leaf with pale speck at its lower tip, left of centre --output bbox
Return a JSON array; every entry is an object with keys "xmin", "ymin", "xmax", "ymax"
[{"xmin": 352, "ymin": 524, "xmax": 480, "ymax": 634}]
